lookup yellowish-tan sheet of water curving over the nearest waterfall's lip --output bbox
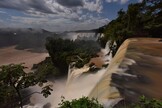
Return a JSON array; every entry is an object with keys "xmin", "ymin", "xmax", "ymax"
[{"xmin": 89, "ymin": 41, "xmax": 132, "ymax": 108}]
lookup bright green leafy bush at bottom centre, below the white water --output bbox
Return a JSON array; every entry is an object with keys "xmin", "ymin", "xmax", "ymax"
[{"xmin": 59, "ymin": 97, "xmax": 103, "ymax": 108}]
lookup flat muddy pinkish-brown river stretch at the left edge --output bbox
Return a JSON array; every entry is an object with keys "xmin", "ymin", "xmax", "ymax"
[{"xmin": 0, "ymin": 46, "xmax": 49, "ymax": 71}]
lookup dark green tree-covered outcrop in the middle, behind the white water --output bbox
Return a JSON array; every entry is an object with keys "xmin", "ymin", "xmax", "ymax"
[{"xmin": 32, "ymin": 37, "xmax": 100, "ymax": 80}]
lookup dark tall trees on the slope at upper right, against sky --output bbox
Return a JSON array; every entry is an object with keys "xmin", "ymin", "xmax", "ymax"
[{"xmin": 99, "ymin": 0, "xmax": 162, "ymax": 54}]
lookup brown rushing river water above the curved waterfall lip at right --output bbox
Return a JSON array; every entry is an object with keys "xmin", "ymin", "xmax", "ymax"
[{"xmin": 111, "ymin": 38, "xmax": 162, "ymax": 102}]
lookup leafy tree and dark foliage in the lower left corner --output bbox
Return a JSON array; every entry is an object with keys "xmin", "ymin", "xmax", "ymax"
[{"xmin": 0, "ymin": 64, "xmax": 52, "ymax": 108}]
